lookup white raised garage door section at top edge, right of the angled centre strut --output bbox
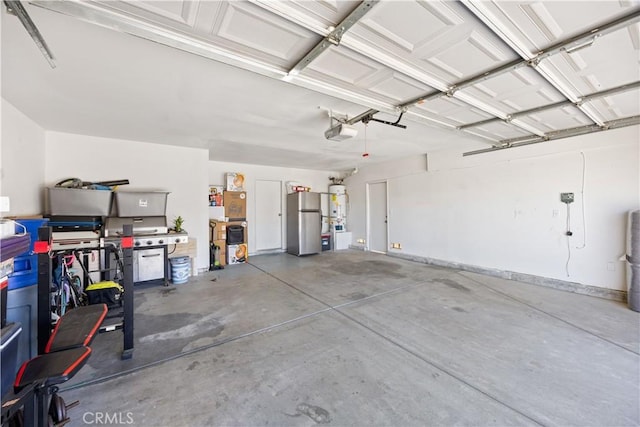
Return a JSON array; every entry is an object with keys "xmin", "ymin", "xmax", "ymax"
[{"xmin": 345, "ymin": 1, "xmax": 516, "ymax": 86}]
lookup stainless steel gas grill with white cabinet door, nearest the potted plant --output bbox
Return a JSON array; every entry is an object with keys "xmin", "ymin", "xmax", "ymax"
[{"xmin": 104, "ymin": 216, "xmax": 189, "ymax": 285}]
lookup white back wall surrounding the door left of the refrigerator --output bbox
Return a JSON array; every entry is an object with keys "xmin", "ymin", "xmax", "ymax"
[{"xmin": 209, "ymin": 161, "xmax": 336, "ymax": 255}]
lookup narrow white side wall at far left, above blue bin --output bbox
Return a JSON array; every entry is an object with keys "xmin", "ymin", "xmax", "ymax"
[{"xmin": 0, "ymin": 98, "xmax": 45, "ymax": 217}]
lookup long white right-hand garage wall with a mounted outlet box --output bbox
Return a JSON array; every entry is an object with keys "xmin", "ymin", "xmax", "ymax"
[{"xmin": 346, "ymin": 126, "xmax": 640, "ymax": 291}]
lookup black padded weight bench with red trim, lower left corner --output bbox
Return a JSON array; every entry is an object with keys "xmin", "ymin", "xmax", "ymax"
[{"xmin": 2, "ymin": 304, "xmax": 107, "ymax": 427}]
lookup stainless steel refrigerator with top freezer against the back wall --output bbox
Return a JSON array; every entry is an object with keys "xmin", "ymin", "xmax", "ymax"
[{"xmin": 287, "ymin": 192, "xmax": 322, "ymax": 255}]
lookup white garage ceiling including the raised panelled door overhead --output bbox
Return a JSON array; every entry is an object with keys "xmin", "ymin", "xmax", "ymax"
[{"xmin": 2, "ymin": 0, "xmax": 640, "ymax": 170}]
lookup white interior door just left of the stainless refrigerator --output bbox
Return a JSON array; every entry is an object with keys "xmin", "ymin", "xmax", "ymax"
[{"xmin": 255, "ymin": 180, "xmax": 282, "ymax": 251}]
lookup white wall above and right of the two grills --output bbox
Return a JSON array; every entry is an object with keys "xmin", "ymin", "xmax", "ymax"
[{"xmin": 45, "ymin": 132, "xmax": 209, "ymax": 269}]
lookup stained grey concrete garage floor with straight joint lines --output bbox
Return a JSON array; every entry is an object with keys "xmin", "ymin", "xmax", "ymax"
[{"xmin": 62, "ymin": 251, "xmax": 640, "ymax": 426}]
